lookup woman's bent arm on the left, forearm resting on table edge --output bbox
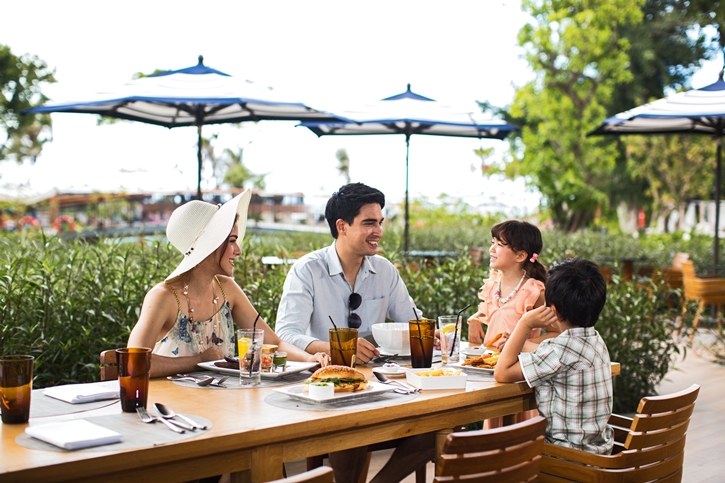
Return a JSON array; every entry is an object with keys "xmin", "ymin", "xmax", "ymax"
[{"xmin": 127, "ymin": 284, "xmax": 223, "ymax": 377}]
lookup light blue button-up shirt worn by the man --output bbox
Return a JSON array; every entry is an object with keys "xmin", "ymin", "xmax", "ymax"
[{"xmin": 275, "ymin": 242, "xmax": 420, "ymax": 350}]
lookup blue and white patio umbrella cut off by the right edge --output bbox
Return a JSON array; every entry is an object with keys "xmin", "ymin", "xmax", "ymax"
[{"xmin": 588, "ymin": 72, "xmax": 725, "ymax": 272}]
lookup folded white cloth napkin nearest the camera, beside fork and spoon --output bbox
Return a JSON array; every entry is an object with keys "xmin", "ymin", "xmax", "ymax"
[{"xmin": 25, "ymin": 419, "xmax": 121, "ymax": 450}]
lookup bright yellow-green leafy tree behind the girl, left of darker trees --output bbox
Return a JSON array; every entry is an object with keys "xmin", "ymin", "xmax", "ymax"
[{"xmin": 506, "ymin": 0, "xmax": 644, "ymax": 231}]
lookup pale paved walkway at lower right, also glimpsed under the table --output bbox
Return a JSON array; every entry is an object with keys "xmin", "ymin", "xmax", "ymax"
[{"xmin": 287, "ymin": 334, "xmax": 725, "ymax": 483}]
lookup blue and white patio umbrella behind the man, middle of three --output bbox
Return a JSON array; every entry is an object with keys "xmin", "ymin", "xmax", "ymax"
[{"xmin": 301, "ymin": 84, "xmax": 519, "ymax": 252}]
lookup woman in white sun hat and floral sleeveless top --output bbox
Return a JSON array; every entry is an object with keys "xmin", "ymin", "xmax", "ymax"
[{"xmin": 128, "ymin": 190, "xmax": 327, "ymax": 377}]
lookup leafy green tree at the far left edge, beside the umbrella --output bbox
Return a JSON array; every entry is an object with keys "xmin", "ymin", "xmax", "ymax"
[{"xmin": 0, "ymin": 44, "xmax": 55, "ymax": 163}]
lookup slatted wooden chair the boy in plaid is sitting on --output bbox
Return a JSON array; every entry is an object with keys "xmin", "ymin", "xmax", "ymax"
[{"xmin": 539, "ymin": 384, "xmax": 700, "ymax": 483}]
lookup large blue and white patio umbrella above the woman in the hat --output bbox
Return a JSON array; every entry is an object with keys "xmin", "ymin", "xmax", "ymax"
[{"xmin": 24, "ymin": 55, "xmax": 344, "ymax": 199}]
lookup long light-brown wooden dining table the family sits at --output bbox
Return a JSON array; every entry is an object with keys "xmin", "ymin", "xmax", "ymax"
[{"xmin": 0, "ymin": 363, "xmax": 619, "ymax": 483}]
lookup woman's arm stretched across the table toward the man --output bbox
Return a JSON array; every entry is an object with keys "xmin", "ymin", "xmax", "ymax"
[{"xmin": 219, "ymin": 276, "xmax": 328, "ymax": 366}]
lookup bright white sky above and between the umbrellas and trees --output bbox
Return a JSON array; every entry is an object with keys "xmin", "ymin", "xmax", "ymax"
[{"xmin": 0, "ymin": 0, "xmax": 722, "ymax": 215}]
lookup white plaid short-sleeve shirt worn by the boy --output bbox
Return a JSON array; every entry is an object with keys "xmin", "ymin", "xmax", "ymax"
[{"xmin": 519, "ymin": 327, "xmax": 614, "ymax": 454}]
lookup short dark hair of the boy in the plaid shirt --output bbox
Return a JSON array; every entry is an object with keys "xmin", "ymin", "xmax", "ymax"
[{"xmin": 545, "ymin": 257, "xmax": 607, "ymax": 327}]
